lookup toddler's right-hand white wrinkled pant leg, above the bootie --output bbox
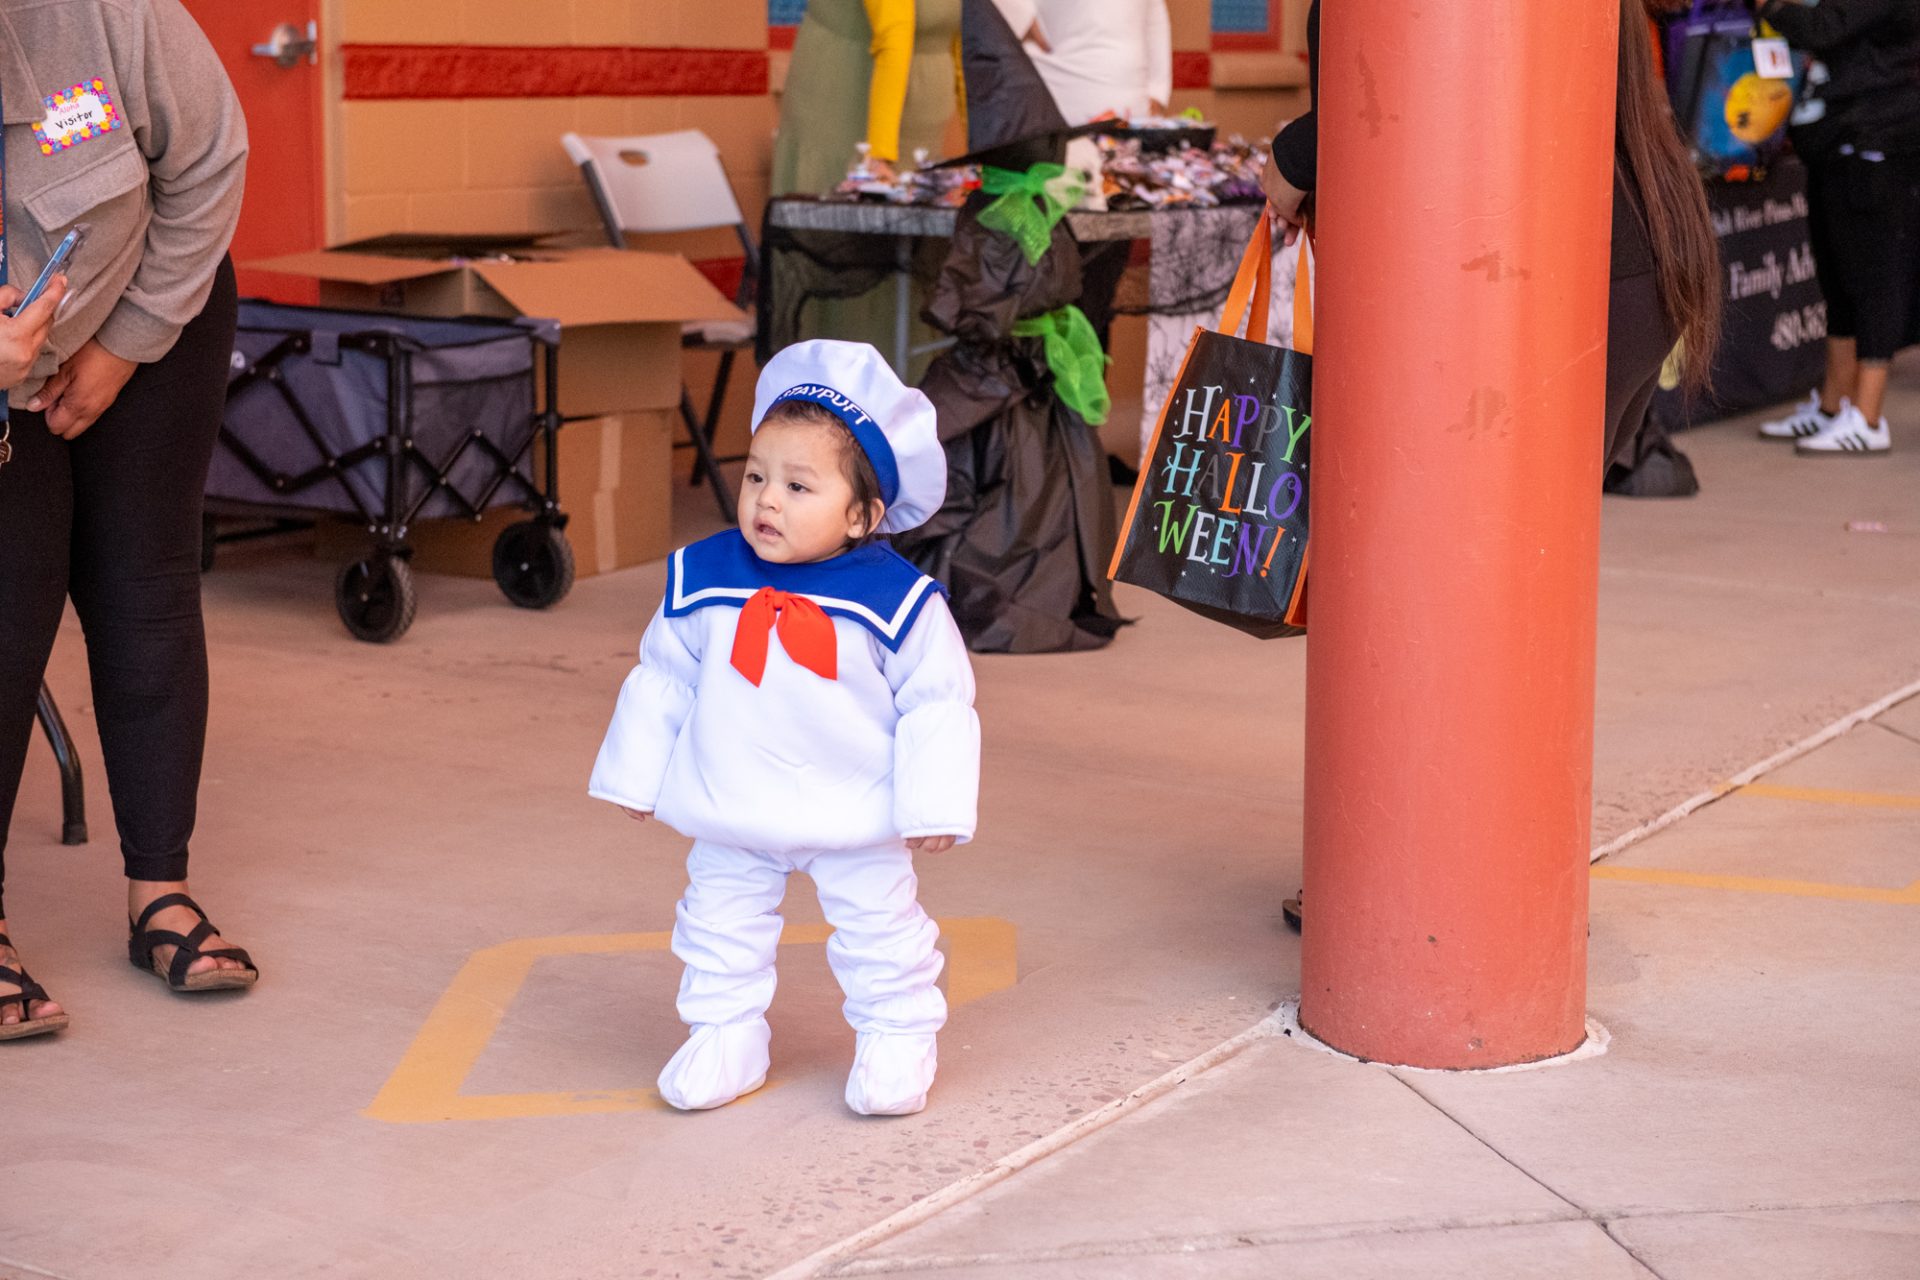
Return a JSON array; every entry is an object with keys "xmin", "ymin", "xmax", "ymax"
[{"xmin": 804, "ymin": 844, "xmax": 947, "ymax": 1034}]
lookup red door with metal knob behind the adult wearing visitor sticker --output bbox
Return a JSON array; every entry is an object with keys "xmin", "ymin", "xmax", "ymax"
[{"xmin": 184, "ymin": 0, "xmax": 326, "ymax": 303}]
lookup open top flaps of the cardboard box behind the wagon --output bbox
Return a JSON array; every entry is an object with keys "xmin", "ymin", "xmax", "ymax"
[{"xmin": 246, "ymin": 248, "xmax": 747, "ymax": 324}]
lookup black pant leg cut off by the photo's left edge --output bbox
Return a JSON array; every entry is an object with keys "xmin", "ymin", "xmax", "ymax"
[{"xmin": 0, "ymin": 402, "xmax": 73, "ymax": 919}]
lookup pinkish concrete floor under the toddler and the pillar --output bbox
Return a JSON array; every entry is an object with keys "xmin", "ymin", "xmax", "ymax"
[{"xmin": 0, "ymin": 367, "xmax": 1920, "ymax": 1280}]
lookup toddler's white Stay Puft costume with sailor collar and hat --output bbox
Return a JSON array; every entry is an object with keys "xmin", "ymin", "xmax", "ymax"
[{"xmin": 589, "ymin": 342, "xmax": 979, "ymax": 1115}]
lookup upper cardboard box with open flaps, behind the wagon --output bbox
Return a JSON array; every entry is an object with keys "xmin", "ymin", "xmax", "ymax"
[{"xmin": 246, "ymin": 236, "xmax": 745, "ymax": 418}]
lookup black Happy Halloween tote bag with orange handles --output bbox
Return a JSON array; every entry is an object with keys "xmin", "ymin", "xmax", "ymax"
[{"xmin": 1108, "ymin": 217, "xmax": 1313, "ymax": 639}]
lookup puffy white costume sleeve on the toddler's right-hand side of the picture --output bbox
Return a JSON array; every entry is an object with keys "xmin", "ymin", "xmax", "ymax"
[{"xmin": 885, "ymin": 597, "xmax": 979, "ymax": 842}]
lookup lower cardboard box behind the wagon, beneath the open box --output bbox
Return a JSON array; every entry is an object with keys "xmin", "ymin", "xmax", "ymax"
[{"xmin": 315, "ymin": 411, "xmax": 678, "ymax": 578}]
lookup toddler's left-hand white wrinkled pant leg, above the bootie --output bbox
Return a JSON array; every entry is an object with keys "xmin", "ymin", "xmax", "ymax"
[{"xmin": 674, "ymin": 841, "xmax": 791, "ymax": 1027}]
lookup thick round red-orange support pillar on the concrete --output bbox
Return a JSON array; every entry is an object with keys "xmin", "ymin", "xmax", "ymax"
[{"xmin": 1300, "ymin": 0, "xmax": 1617, "ymax": 1067}]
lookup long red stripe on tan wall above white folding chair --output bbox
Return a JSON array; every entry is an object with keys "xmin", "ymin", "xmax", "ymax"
[{"xmin": 340, "ymin": 44, "xmax": 768, "ymax": 100}]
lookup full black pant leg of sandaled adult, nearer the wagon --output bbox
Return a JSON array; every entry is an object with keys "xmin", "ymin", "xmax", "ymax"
[{"xmin": 69, "ymin": 263, "xmax": 236, "ymax": 881}]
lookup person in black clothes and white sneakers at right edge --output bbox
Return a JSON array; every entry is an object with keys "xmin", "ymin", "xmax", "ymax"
[{"xmin": 1757, "ymin": 0, "xmax": 1920, "ymax": 455}]
